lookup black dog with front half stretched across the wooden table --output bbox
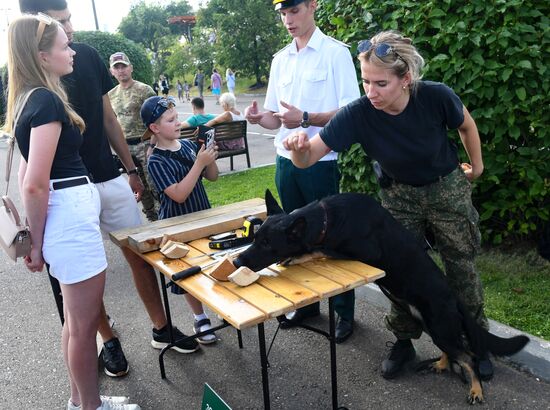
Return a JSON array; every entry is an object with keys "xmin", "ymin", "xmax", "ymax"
[{"xmin": 235, "ymin": 191, "xmax": 529, "ymax": 404}]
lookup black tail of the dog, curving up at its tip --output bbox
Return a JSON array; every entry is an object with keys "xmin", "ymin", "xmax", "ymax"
[{"xmin": 459, "ymin": 302, "xmax": 529, "ymax": 357}]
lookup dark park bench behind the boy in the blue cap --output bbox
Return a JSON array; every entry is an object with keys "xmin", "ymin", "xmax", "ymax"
[{"xmin": 181, "ymin": 121, "xmax": 250, "ymax": 171}]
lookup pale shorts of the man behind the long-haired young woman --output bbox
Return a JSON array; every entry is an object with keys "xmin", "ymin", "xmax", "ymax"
[{"xmin": 95, "ymin": 175, "xmax": 143, "ymax": 238}]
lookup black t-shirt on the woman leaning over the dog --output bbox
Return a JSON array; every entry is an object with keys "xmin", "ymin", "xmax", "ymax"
[{"xmin": 320, "ymin": 81, "xmax": 464, "ymax": 185}]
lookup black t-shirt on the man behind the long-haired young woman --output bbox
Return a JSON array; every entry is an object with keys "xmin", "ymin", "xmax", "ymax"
[{"xmin": 63, "ymin": 43, "xmax": 120, "ymax": 182}]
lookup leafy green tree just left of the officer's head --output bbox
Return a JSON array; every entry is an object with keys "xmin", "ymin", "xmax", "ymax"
[{"xmin": 195, "ymin": 0, "xmax": 285, "ymax": 85}]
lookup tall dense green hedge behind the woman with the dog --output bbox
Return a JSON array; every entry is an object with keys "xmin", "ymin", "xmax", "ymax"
[{"xmin": 317, "ymin": 0, "xmax": 550, "ymax": 243}]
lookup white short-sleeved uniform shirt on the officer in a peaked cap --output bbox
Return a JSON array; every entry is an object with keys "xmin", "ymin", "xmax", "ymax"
[{"xmin": 264, "ymin": 27, "xmax": 360, "ymax": 161}]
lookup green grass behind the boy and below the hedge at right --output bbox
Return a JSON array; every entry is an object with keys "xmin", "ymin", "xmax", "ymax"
[{"xmin": 205, "ymin": 165, "xmax": 550, "ymax": 340}]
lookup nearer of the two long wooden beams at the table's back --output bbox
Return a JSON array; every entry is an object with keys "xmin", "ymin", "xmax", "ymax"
[{"xmin": 128, "ymin": 205, "xmax": 266, "ymax": 253}]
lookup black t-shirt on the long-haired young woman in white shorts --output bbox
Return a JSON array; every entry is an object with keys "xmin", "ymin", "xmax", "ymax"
[{"xmin": 15, "ymin": 88, "xmax": 88, "ymax": 179}]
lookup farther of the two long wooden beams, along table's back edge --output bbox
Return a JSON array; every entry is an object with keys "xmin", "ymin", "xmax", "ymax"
[{"xmin": 109, "ymin": 198, "xmax": 265, "ymax": 247}]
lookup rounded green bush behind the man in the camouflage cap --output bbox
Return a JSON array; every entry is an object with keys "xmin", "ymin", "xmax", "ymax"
[{"xmin": 74, "ymin": 31, "xmax": 153, "ymax": 84}]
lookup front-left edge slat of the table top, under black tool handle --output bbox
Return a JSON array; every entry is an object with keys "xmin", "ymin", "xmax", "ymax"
[{"xmin": 141, "ymin": 252, "xmax": 268, "ymax": 329}]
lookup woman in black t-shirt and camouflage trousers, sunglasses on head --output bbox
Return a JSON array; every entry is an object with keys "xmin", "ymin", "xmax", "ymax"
[{"xmin": 284, "ymin": 31, "xmax": 493, "ymax": 380}]
